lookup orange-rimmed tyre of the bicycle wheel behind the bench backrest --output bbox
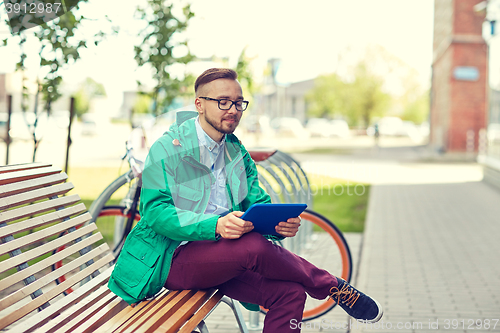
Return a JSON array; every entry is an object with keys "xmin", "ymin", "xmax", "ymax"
[{"xmin": 52, "ymin": 206, "xmax": 141, "ymax": 295}]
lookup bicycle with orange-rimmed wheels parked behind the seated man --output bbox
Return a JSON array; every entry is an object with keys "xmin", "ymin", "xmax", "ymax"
[{"xmin": 52, "ymin": 134, "xmax": 352, "ymax": 321}]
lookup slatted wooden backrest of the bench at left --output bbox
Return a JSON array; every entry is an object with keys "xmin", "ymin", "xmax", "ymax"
[{"xmin": 0, "ymin": 163, "xmax": 115, "ymax": 332}]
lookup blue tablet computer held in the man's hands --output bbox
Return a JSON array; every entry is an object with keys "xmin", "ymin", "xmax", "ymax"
[{"xmin": 240, "ymin": 203, "xmax": 307, "ymax": 237}]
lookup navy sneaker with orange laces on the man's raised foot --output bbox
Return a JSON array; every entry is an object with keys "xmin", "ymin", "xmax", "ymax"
[{"xmin": 330, "ymin": 278, "xmax": 383, "ymax": 323}]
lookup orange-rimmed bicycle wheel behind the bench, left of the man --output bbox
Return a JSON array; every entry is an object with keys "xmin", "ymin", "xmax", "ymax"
[{"xmin": 52, "ymin": 206, "xmax": 141, "ymax": 295}]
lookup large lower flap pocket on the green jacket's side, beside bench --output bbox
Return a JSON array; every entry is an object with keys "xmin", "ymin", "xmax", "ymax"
[{"xmin": 113, "ymin": 237, "xmax": 160, "ymax": 299}]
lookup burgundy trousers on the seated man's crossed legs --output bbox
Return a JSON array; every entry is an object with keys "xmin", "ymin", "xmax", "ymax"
[{"xmin": 165, "ymin": 232, "xmax": 337, "ymax": 333}]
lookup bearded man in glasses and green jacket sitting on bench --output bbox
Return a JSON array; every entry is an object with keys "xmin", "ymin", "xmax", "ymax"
[{"xmin": 109, "ymin": 68, "xmax": 382, "ymax": 333}]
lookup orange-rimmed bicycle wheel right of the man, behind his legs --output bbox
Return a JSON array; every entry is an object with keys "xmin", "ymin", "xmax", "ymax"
[{"xmin": 261, "ymin": 209, "xmax": 352, "ymax": 321}]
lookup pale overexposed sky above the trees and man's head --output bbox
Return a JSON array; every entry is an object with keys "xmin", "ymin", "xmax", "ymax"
[{"xmin": 0, "ymin": 0, "xmax": 474, "ymax": 109}]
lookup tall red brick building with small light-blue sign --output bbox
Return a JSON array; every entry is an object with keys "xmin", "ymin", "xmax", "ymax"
[{"xmin": 430, "ymin": 0, "xmax": 489, "ymax": 153}]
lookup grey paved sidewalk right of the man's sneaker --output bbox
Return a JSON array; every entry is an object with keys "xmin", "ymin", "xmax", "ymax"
[{"xmin": 351, "ymin": 182, "xmax": 500, "ymax": 332}]
